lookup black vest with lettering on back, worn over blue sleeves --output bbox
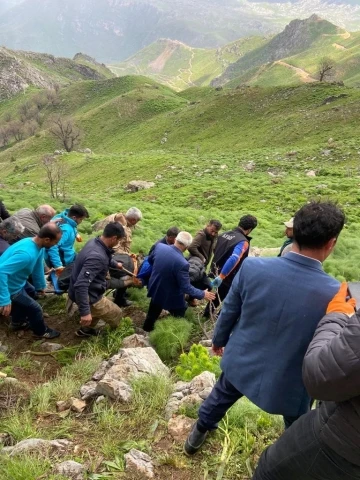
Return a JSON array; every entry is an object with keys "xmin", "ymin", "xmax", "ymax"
[{"xmin": 211, "ymin": 227, "xmax": 251, "ymax": 286}]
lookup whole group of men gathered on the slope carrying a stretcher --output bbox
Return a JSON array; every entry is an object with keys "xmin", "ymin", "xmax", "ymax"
[{"xmin": 0, "ymin": 197, "xmax": 360, "ymax": 480}]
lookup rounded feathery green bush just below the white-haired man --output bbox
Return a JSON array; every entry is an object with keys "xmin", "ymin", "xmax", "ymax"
[{"xmin": 150, "ymin": 317, "xmax": 193, "ymax": 361}]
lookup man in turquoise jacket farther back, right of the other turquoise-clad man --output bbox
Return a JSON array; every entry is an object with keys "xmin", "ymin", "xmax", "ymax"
[{"xmin": 45, "ymin": 205, "xmax": 89, "ymax": 274}]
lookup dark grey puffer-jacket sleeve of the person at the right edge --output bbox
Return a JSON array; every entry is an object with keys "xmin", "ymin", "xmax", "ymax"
[{"xmin": 303, "ymin": 313, "xmax": 360, "ymax": 402}]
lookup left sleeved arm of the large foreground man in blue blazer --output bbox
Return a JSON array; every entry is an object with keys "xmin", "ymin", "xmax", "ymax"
[{"xmin": 213, "ymin": 261, "xmax": 246, "ymax": 347}]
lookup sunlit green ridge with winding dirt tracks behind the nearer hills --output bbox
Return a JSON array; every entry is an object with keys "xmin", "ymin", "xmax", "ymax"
[{"xmin": 110, "ymin": 15, "xmax": 360, "ymax": 90}]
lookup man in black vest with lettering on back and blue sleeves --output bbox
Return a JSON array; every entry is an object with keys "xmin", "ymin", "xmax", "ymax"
[{"xmin": 204, "ymin": 215, "xmax": 257, "ymax": 318}]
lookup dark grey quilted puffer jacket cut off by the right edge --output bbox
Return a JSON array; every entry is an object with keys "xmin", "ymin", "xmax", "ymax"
[{"xmin": 303, "ymin": 311, "xmax": 360, "ymax": 466}]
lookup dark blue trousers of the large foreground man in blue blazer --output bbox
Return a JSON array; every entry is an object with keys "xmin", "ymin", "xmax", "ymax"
[{"xmin": 198, "ymin": 373, "xmax": 299, "ymax": 431}]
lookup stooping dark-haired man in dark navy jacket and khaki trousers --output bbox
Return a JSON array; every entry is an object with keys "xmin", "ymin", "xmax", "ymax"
[{"xmin": 67, "ymin": 222, "xmax": 125, "ymax": 337}]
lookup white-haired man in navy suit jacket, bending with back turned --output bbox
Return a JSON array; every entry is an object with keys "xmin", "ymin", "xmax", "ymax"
[{"xmin": 143, "ymin": 232, "xmax": 215, "ymax": 332}]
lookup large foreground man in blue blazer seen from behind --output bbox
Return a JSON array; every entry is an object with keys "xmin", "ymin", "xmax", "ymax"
[{"xmin": 185, "ymin": 202, "xmax": 345, "ymax": 455}]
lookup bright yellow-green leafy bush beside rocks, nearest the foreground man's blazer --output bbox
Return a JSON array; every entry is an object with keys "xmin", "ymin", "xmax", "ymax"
[{"xmin": 175, "ymin": 344, "xmax": 221, "ymax": 382}]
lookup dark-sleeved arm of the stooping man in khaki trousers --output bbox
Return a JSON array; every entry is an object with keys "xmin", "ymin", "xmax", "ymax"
[{"xmin": 74, "ymin": 257, "xmax": 103, "ymax": 317}]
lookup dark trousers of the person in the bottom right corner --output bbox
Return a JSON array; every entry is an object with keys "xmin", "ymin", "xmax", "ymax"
[{"xmin": 253, "ymin": 410, "xmax": 360, "ymax": 480}]
